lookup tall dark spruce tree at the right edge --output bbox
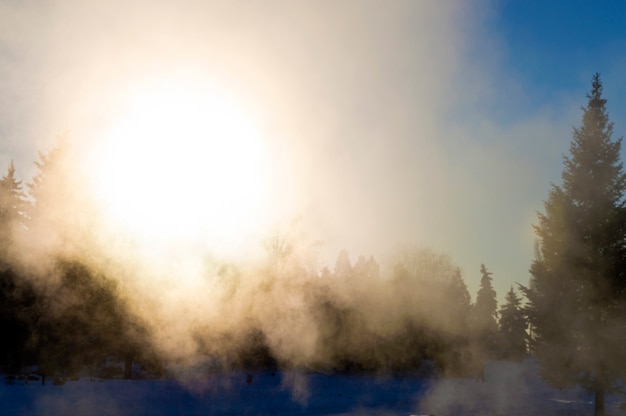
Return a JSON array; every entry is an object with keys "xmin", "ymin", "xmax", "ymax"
[{"xmin": 524, "ymin": 74, "xmax": 626, "ymax": 416}]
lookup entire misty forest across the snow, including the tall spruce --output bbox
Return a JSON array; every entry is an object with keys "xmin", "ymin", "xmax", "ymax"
[{"xmin": 0, "ymin": 74, "xmax": 626, "ymax": 414}]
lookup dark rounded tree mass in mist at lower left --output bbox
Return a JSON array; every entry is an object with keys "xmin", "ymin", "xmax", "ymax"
[{"xmin": 34, "ymin": 260, "xmax": 151, "ymax": 378}]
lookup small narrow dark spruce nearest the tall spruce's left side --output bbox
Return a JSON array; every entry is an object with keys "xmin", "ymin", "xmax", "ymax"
[{"xmin": 499, "ymin": 287, "xmax": 528, "ymax": 361}]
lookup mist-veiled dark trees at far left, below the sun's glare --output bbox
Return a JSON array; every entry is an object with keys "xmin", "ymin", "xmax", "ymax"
[{"xmin": 0, "ymin": 145, "xmax": 158, "ymax": 380}]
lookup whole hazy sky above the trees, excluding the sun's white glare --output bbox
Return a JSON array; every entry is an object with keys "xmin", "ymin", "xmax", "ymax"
[{"xmin": 0, "ymin": 0, "xmax": 626, "ymax": 297}]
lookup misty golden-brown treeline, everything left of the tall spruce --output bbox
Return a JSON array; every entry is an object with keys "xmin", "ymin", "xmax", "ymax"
[{"xmin": 0, "ymin": 141, "xmax": 528, "ymax": 378}]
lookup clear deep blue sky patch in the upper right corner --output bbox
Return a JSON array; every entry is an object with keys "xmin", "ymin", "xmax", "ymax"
[{"xmin": 488, "ymin": 1, "xmax": 626, "ymax": 117}]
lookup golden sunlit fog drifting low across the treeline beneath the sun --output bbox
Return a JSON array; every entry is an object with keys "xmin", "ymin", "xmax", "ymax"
[{"xmin": 5, "ymin": 139, "xmax": 481, "ymax": 374}]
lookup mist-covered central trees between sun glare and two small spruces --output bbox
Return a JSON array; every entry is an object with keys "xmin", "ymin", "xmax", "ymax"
[{"xmin": 191, "ymin": 245, "xmax": 482, "ymax": 375}]
